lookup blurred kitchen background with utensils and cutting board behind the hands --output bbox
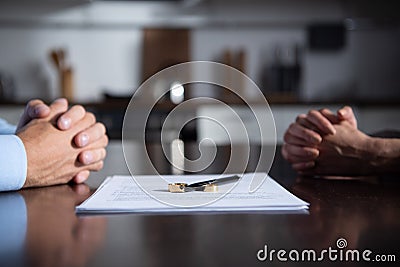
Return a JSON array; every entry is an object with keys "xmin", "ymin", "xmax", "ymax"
[{"xmin": 0, "ymin": 0, "xmax": 400, "ymax": 182}]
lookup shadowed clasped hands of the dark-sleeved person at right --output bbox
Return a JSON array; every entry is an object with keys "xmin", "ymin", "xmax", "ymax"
[{"xmin": 282, "ymin": 106, "xmax": 382, "ymax": 176}]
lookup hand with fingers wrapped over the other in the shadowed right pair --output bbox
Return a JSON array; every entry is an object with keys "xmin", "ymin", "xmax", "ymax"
[{"xmin": 282, "ymin": 106, "xmax": 357, "ymax": 172}]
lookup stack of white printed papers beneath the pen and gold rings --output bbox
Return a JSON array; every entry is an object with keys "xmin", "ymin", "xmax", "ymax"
[{"xmin": 76, "ymin": 173, "xmax": 309, "ymax": 216}]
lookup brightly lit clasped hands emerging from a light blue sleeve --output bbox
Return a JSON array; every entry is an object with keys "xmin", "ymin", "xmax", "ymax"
[{"xmin": 16, "ymin": 99, "xmax": 108, "ymax": 187}]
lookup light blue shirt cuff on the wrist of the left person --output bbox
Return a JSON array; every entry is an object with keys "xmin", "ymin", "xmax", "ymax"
[{"xmin": 0, "ymin": 135, "xmax": 28, "ymax": 191}]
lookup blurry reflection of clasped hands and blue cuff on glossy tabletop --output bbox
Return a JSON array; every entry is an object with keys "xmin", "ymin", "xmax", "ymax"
[{"xmin": 0, "ymin": 185, "xmax": 106, "ymax": 267}]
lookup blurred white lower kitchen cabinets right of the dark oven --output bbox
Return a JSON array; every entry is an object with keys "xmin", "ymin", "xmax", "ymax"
[{"xmin": 197, "ymin": 104, "xmax": 400, "ymax": 145}]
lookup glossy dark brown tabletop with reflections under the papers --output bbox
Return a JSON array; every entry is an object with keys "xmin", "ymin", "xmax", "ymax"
[{"xmin": 0, "ymin": 143, "xmax": 400, "ymax": 266}]
